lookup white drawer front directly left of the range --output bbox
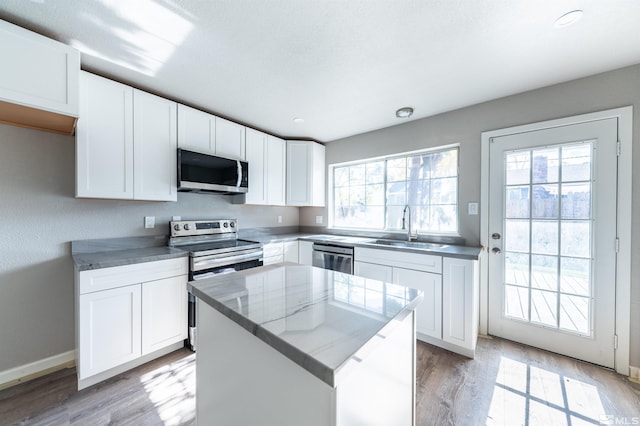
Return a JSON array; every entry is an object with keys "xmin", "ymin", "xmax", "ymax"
[{"xmin": 79, "ymin": 257, "xmax": 189, "ymax": 294}]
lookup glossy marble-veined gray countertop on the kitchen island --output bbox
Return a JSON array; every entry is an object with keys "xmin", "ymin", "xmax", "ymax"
[{"xmin": 188, "ymin": 263, "xmax": 423, "ymax": 386}]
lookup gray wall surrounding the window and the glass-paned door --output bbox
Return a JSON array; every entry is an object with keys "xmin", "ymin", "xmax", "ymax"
[{"xmin": 300, "ymin": 65, "xmax": 640, "ymax": 366}]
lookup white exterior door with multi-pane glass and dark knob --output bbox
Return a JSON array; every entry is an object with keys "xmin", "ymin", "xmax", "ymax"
[{"xmin": 488, "ymin": 118, "xmax": 617, "ymax": 368}]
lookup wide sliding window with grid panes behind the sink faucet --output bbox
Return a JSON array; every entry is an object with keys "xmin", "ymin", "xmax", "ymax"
[{"xmin": 332, "ymin": 147, "xmax": 458, "ymax": 234}]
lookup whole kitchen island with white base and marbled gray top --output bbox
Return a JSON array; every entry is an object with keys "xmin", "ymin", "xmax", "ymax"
[{"xmin": 189, "ymin": 263, "xmax": 422, "ymax": 425}]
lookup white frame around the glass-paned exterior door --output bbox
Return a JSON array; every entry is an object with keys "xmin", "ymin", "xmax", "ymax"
[{"xmin": 479, "ymin": 106, "xmax": 633, "ymax": 376}]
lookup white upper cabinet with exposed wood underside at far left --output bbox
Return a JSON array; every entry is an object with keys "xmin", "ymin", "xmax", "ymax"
[{"xmin": 0, "ymin": 21, "xmax": 80, "ymax": 134}]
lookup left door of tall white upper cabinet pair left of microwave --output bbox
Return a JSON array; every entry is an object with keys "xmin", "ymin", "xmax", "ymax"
[{"xmin": 76, "ymin": 72, "xmax": 133, "ymax": 200}]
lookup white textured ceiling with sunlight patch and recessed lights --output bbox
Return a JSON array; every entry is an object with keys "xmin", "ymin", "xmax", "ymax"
[{"xmin": 0, "ymin": 0, "xmax": 640, "ymax": 142}]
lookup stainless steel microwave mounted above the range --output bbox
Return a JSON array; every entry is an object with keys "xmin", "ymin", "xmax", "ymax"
[{"xmin": 178, "ymin": 148, "xmax": 249, "ymax": 194}]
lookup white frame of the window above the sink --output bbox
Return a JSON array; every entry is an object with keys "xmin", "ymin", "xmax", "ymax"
[{"xmin": 327, "ymin": 143, "xmax": 460, "ymax": 237}]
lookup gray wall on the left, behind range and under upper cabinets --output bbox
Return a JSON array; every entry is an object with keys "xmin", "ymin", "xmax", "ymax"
[{"xmin": 0, "ymin": 125, "xmax": 299, "ymax": 371}]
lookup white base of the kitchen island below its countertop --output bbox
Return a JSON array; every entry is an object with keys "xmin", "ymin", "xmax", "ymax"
[{"xmin": 196, "ymin": 300, "xmax": 416, "ymax": 426}]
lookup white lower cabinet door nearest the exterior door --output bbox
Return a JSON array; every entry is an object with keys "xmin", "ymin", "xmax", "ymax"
[{"xmin": 442, "ymin": 257, "xmax": 479, "ymax": 350}]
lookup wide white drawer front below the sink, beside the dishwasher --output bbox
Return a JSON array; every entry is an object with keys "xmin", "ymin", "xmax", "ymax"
[{"xmin": 354, "ymin": 247, "xmax": 442, "ymax": 274}]
